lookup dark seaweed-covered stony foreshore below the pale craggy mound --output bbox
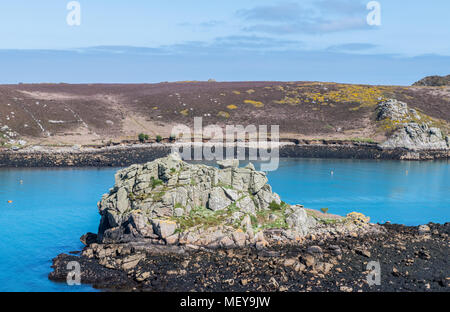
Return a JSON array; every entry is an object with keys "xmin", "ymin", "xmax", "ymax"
[{"xmin": 49, "ymin": 223, "xmax": 450, "ymax": 292}]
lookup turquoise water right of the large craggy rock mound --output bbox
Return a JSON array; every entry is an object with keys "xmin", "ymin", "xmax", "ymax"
[{"xmin": 268, "ymin": 159, "xmax": 450, "ymax": 225}]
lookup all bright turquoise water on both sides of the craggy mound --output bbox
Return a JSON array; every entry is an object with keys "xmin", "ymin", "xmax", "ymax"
[{"xmin": 0, "ymin": 159, "xmax": 450, "ymax": 291}]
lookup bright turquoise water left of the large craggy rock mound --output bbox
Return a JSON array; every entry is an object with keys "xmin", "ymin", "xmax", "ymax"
[{"xmin": 0, "ymin": 169, "xmax": 115, "ymax": 291}]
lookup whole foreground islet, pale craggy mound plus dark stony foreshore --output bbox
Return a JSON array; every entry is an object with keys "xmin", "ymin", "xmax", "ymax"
[{"xmin": 49, "ymin": 154, "xmax": 450, "ymax": 292}]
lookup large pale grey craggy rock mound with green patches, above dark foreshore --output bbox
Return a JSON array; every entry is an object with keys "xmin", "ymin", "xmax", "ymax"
[{"xmin": 98, "ymin": 154, "xmax": 315, "ymax": 247}]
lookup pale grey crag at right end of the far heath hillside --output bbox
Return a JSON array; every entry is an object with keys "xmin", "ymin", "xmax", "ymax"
[{"xmin": 377, "ymin": 99, "xmax": 450, "ymax": 150}]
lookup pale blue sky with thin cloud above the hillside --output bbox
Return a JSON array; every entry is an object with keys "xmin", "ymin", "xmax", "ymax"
[{"xmin": 0, "ymin": 0, "xmax": 450, "ymax": 84}]
